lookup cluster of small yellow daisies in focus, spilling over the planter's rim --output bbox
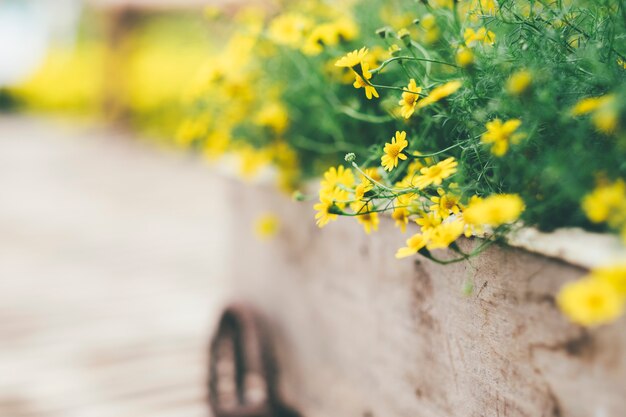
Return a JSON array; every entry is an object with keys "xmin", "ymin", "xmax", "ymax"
[{"xmin": 314, "ymin": 131, "xmax": 524, "ymax": 262}]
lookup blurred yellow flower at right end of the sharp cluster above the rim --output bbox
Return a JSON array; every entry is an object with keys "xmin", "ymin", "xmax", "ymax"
[{"xmin": 463, "ymin": 194, "xmax": 524, "ymax": 227}]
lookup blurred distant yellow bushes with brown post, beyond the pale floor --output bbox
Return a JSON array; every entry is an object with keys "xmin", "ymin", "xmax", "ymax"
[{"xmin": 0, "ymin": 0, "xmax": 244, "ymax": 136}]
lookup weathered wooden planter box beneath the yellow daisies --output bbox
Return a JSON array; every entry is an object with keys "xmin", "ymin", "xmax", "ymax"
[{"xmin": 213, "ymin": 175, "xmax": 626, "ymax": 417}]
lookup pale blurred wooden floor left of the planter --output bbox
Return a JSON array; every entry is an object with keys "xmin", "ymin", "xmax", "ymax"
[{"xmin": 0, "ymin": 117, "xmax": 235, "ymax": 417}]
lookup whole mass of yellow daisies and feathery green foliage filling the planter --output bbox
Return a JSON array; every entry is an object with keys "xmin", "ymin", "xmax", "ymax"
[{"xmin": 178, "ymin": 0, "xmax": 626, "ymax": 322}]
